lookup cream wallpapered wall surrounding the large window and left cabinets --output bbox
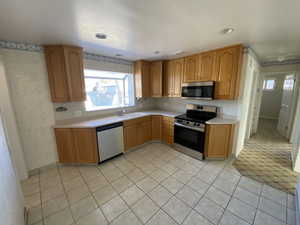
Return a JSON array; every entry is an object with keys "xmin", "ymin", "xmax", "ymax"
[{"xmin": 0, "ymin": 49, "xmax": 153, "ymax": 170}]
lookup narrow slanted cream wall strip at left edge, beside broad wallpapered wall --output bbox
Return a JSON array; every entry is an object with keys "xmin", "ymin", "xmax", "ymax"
[{"xmin": 0, "ymin": 55, "xmax": 28, "ymax": 180}]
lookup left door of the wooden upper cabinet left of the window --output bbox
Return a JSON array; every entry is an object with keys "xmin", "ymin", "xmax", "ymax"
[{"xmin": 44, "ymin": 46, "xmax": 70, "ymax": 102}]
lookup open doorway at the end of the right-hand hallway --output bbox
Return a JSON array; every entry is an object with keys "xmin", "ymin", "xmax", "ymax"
[{"xmin": 248, "ymin": 73, "xmax": 296, "ymax": 146}]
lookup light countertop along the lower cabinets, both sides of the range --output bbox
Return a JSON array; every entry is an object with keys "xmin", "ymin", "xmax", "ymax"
[{"xmin": 54, "ymin": 110, "xmax": 237, "ymax": 128}]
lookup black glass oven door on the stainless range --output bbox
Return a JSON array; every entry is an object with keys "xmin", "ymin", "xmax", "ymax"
[{"xmin": 174, "ymin": 123, "xmax": 205, "ymax": 154}]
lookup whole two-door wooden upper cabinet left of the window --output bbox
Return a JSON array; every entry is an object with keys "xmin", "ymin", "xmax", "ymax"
[{"xmin": 44, "ymin": 45, "xmax": 86, "ymax": 102}]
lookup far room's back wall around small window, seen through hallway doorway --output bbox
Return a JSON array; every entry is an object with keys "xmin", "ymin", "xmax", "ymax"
[{"xmin": 259, "ymin": 74, "xmax": 287, "ymax": 119}]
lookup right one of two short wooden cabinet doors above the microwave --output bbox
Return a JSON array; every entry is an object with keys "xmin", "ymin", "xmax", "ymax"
[{"xmin": 198, "ymin": 51, "xmax": 216, "ymax": 81}]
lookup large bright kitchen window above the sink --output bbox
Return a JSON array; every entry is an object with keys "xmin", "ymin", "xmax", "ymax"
[{"xmin": 84, "ymin": 70, "xmax": 135, "ymax": 111}]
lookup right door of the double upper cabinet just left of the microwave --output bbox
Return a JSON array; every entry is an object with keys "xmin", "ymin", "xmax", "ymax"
[{"xmin": 173, "ymin": 59, "xmax": 184, "ymax": 97}]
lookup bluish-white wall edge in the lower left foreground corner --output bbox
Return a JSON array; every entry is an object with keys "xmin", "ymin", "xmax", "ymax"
[{"xmin": 0, "ymin": 113, "xmax": 24, "ymax": 225}]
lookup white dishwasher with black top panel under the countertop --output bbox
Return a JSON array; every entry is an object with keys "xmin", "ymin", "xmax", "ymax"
[{"xmin": 96, "ymin": 122, "xmax": 124, "ymax": 162}]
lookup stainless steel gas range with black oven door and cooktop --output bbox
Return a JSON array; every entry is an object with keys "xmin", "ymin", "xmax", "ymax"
[{"xmin": 174, "ymin": 104, "xmax": 217, "ymax": 159}]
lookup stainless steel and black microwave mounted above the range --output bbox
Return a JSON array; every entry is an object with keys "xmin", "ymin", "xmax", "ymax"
[{"xmin": 181, "ymin": 81, "xmax": 215, "ymax": 100}]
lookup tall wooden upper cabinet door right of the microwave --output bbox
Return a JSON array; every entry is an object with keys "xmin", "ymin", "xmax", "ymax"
[{"xmin": 215, "ymin": 46, "xmax": 242, "ymax": 99}]
